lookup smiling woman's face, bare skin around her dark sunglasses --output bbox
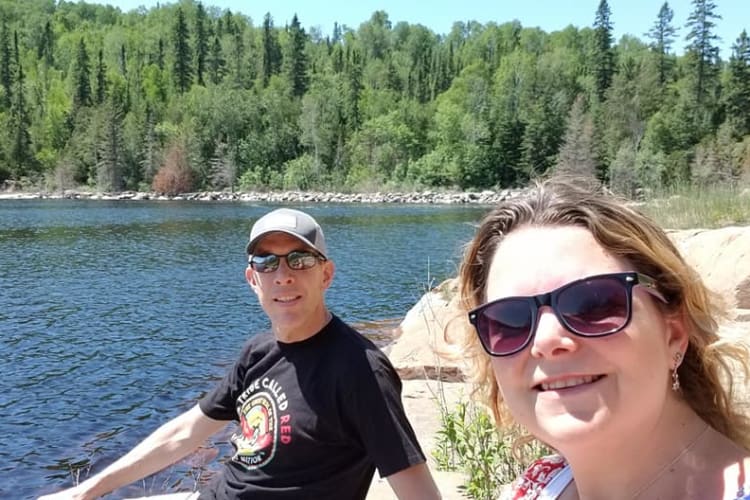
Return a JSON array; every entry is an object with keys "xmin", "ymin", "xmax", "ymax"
[{"xmin": 486, "ymin": 226, "xmax": 687, "ymax": 451}]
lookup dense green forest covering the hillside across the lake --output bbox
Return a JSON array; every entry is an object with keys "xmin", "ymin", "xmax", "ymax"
[{"xmin": 0, "ymin": 0, "xmax": 750, "ymax": 194}]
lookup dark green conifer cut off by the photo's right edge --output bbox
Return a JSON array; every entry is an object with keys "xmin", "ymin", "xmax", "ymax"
[{"xmin": 724, "ymin": 30, "xmax": 750, "ymax": 139}]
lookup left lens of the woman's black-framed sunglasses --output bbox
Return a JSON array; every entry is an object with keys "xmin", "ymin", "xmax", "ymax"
[{"xmin": 477, "ymin": 299, "xmax": 533, "ymax": 354}]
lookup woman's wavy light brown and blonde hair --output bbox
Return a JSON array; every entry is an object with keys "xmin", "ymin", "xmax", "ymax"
[{"xmin": 459, "ymin": 178, "xmax": 750, "ymax": 449}]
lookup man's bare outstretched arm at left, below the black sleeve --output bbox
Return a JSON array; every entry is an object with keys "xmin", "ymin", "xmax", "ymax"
[{"xmin": 39, "ymin": 405, "xmax": 226, "ymax": 500}]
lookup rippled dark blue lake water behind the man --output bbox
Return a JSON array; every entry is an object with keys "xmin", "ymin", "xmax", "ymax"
[{"xmin": 0, "ymin": 200, "xmax": 486, "ymax": 499}]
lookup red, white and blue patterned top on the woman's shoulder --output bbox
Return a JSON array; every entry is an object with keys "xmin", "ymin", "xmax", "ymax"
[{"xmin": 500, "ymin": 455, "xmax": 750, "ymax": 500}]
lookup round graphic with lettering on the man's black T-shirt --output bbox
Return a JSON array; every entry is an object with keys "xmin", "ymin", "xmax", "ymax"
[{"xmin": 232, "ymin": 377, "xmax": 291, "ymax": 470}]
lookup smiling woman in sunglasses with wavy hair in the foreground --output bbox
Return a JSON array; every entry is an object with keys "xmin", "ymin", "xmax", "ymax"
[{"xmin": 460, "ymin": 179, "xmax": 750, "ymax": 500}]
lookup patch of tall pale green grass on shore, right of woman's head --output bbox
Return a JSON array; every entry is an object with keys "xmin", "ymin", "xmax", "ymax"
[{"xmin": 638, "ymin": 186, "xmax": 750, "ymax": 229}]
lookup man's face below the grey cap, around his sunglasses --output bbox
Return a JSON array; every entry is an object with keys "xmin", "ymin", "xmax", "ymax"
[{"xmin": 245, "ymin": 233, "xmax": 334, "ymax": 342}]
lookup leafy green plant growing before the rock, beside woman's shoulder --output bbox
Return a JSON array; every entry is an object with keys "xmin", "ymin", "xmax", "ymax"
[{"xmin": 433, "ymin": 401, "xmax": 550, "ymax": 500}]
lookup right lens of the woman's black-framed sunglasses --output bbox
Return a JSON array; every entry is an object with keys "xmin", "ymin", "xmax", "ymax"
[{"xmin": 557, "ymin": 277, "xmax": 628, "ymax": 335}]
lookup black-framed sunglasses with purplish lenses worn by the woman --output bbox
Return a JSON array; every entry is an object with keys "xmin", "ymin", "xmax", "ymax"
[{"xmin": 469, "ymin": 272, "xmax": 667, "ymax": 356}]
